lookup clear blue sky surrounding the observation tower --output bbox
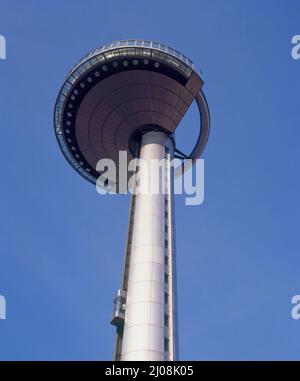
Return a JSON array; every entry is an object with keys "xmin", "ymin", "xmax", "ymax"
[{"xmin": 0, "ymin": 0, "xmax": 300, "ymax": 360}]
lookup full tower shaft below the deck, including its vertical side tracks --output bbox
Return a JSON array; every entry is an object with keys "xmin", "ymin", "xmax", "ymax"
[{"xmin": 115, "ymin": 131, "xmax": 176, "ymax": 361}]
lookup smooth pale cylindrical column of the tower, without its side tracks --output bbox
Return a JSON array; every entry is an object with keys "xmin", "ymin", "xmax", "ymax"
[{"xmin": 121, "ymin": 131, "xmax": 173, "ymax": 361}]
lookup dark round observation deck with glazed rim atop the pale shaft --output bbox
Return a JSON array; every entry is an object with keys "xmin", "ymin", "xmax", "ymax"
[{"xmin": 54, "ymin": 40, "xmax": 210, "ymax": 183}]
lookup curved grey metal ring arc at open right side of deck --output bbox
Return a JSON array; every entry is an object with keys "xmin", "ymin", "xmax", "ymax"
[{"xmin": 174, "ymin": 90, "xmax": 210, "ymax": 178}]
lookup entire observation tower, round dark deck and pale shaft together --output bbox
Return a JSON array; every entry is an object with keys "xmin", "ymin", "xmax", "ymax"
[{"xmin": 54, "ymin": 40, "xmax": 210, "ymax": 361}]
